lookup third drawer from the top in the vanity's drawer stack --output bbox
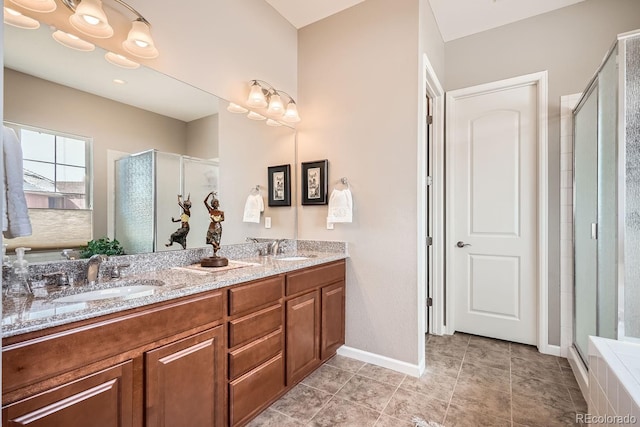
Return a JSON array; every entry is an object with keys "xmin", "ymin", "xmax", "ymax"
[{"xmin": 229, "ymin": 328, "xmax": 283, "ymax": 380}]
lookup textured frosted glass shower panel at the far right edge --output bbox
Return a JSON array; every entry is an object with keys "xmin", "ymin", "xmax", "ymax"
[{"xmin": 623, "ymin": 36, "xmax": 640, "ymax": 339}]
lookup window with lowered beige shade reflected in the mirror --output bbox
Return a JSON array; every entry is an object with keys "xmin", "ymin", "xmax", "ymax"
[{"xmin": 5, "ymin": 123, "xmax": 92, "ymax": 249}]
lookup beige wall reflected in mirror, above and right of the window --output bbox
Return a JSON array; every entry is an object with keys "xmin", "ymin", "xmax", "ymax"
[{"xmin": 4, "ymin": 69, "xmax": 187, "ymax": 238}]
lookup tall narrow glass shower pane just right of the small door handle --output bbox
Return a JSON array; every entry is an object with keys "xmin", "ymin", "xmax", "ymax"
[{"xmin": 597, "ymin": 50, "xmax": 618, "ymax": 339}]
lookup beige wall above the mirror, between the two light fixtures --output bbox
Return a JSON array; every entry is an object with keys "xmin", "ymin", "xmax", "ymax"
[{"xmin": 129, "ymin": 0, "xmax": 297, "ymax": 107}]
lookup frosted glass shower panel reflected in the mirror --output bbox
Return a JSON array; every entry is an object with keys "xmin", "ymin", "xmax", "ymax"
[{"xmin": 115, "ymin": 152, "xmax": 155, "ymax": 254}]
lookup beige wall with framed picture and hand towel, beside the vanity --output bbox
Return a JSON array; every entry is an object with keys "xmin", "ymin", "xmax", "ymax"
[{"xmin": 298, "ymin": 0, "xmax": 443, "ymax": 364}]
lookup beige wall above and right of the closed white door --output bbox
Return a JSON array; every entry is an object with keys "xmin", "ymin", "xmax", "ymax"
[{"xmin": 445, "ymin": 0, "xmax": 640, "ymax": 345}]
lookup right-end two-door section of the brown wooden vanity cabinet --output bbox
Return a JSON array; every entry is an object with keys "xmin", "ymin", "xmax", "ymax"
[{"xmin": 286, "ymin": 261, "xmax": 345, "ymax": 387}]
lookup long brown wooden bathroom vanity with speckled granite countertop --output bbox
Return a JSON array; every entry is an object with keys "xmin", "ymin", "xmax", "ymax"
[{"xmin": 2, "ymin": 247, "xmax": 346, "ymax": 427}]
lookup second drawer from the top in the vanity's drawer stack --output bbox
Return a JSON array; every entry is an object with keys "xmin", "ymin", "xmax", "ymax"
[{"xmin": 229, "ymin": 304, "xmax": 282, "ymax": 348}]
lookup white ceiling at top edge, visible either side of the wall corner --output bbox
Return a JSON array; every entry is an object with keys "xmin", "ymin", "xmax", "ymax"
[{"xmin": 266, "ymin": 0, "xmax": 584, "ymax": 42}]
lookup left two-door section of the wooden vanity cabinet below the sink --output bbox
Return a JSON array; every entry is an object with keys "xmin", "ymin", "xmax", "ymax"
[{"xmin": 2, "ymin": 291, "xmax": 226, "ymax": 427}]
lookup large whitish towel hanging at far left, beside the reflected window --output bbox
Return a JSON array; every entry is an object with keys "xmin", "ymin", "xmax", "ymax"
[{"xmin": 2, "ymin": 126, "xmax": 31, "ymax": 239}]
